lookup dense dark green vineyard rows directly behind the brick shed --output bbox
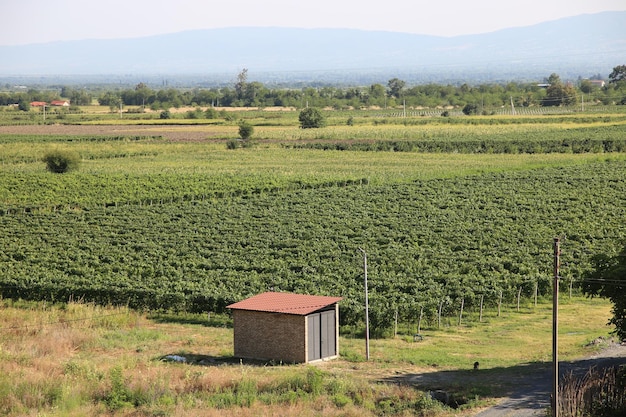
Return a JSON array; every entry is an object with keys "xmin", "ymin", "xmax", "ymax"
[{"xmin": 0, "ymin": 160, "xmax": 626, "ymax": 331}]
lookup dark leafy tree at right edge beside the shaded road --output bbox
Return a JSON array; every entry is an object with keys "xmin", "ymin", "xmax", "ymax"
[{"xmin": 583, "ymin": 246, "xmax": 626, "ymax": 340}]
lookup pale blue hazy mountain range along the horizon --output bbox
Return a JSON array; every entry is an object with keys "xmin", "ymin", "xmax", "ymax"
[{"xmin": 0, "ymin": 12, "xmax": 626, "ymax": 82}]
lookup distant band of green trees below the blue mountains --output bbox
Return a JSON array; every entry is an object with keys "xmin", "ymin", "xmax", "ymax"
[{"xmin": 0, "ymin": 65, "xmax": 626, "ymax": 110}]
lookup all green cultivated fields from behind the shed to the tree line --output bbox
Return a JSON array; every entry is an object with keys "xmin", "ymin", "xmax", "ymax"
[{"xmin": 0, "ymin": 109, "xmax": 626, "ymax": 334}]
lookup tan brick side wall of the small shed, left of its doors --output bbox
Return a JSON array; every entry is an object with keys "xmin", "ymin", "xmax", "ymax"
[{"xmin": 233, "ymin": 310, "xmax": 307, "ymax": 363}]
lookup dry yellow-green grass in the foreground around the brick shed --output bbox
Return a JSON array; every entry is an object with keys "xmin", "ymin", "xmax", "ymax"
[{"xmin": 0, "ymin": 297, "xmax": 609, "ymax": 416}]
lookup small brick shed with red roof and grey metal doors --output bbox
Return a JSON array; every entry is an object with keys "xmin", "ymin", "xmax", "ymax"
[{"xmin": 228, "ymin": 292, "xmax": 341, "ymax": 363}]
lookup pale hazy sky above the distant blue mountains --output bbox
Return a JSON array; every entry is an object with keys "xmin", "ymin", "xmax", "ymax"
[{"xmin": 0, "ymin": 0, "xmax": 626, "ymax": 45}]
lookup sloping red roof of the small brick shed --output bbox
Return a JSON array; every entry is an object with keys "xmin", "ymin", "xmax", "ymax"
[{"xmin": 227, "ymin": 292, "xmax": 342, "ymax": 316}]
